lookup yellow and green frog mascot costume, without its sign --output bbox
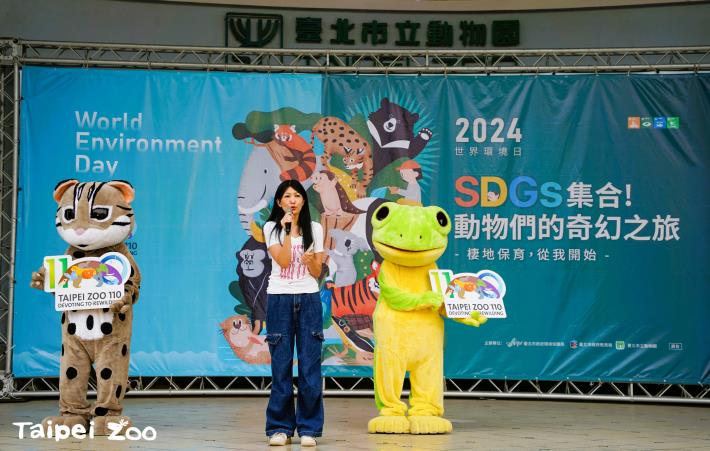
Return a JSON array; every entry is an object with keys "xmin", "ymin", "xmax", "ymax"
[{"xmin": 367, "ymin": 202, "xmax": 486, "ymax": 434}]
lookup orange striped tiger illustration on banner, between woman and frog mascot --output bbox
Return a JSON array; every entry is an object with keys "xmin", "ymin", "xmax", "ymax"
[{"xmin": 325, "ymin": 260, "xmax": 380, "ymax": 361}]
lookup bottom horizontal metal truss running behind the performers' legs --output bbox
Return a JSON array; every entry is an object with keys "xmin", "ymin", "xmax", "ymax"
[{"xmin": 0, "ymin": 376, "xmax": 710, "ymax": 405}]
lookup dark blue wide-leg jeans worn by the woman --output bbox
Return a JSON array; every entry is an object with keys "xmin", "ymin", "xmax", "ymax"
[{"xmin": 266, "ymin": 293, "xmax": 324, "ymax": 437}]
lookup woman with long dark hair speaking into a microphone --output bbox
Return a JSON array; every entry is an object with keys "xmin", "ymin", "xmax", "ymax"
[{"xmin": 264, "ymin": 180, "xmax": 323, "ymax": 446}]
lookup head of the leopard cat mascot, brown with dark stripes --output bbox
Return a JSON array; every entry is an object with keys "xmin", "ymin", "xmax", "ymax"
[{"xmin": 54, "ymin": 180, "xmax": 135, "ymax": 251}]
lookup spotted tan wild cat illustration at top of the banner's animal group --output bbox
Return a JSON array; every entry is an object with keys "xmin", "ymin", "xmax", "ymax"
[{"xmin": 311, "ymin": 117, "xmax": 373, "ymax": 198}]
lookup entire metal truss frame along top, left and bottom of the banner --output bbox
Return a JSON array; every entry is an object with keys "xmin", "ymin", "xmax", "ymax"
[{"xmin": 0, "ymin": 39, "xmax": 710, "ymax": 405}]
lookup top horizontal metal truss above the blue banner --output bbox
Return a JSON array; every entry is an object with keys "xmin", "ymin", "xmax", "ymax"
[{"xmin": 17, "ymin": 41, "xmax": 710, "ymax": 74}]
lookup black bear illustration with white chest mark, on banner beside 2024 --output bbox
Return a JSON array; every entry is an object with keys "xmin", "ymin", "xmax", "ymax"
[{"xmin": 367, "ymin": 97, "xmax": 433, "ymax": 174}]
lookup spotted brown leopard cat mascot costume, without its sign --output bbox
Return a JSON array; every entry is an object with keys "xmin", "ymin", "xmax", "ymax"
[{"xmin": 30, "ymin": 180, "xmax": 141, "ymax": 435}]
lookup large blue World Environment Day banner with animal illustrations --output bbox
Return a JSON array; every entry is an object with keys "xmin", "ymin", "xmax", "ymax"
[{"xmin": 13, "ymin": 67, "xmax": 710, "ymax": 383}]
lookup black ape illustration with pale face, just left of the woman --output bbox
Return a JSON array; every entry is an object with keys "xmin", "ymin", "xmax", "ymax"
[{"xmin": 237, "ymin": 237, "xmax": 271, "ymax": 335}]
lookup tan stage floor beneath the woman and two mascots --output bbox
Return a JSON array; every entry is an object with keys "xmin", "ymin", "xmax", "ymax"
[{"xmin": 0, "ymin": 397, "xmax": 710, "ymax": 451}]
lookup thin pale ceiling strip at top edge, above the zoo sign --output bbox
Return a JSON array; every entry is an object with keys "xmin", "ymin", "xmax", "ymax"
[{"xmin": 161, "ymin": 0, "xmax": 702, "ymax": 12}]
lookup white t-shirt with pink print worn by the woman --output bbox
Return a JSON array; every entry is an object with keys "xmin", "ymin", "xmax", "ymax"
[{"xmin": 264, "ymin": 221, "xmax": 323, "ymax": 294}]
